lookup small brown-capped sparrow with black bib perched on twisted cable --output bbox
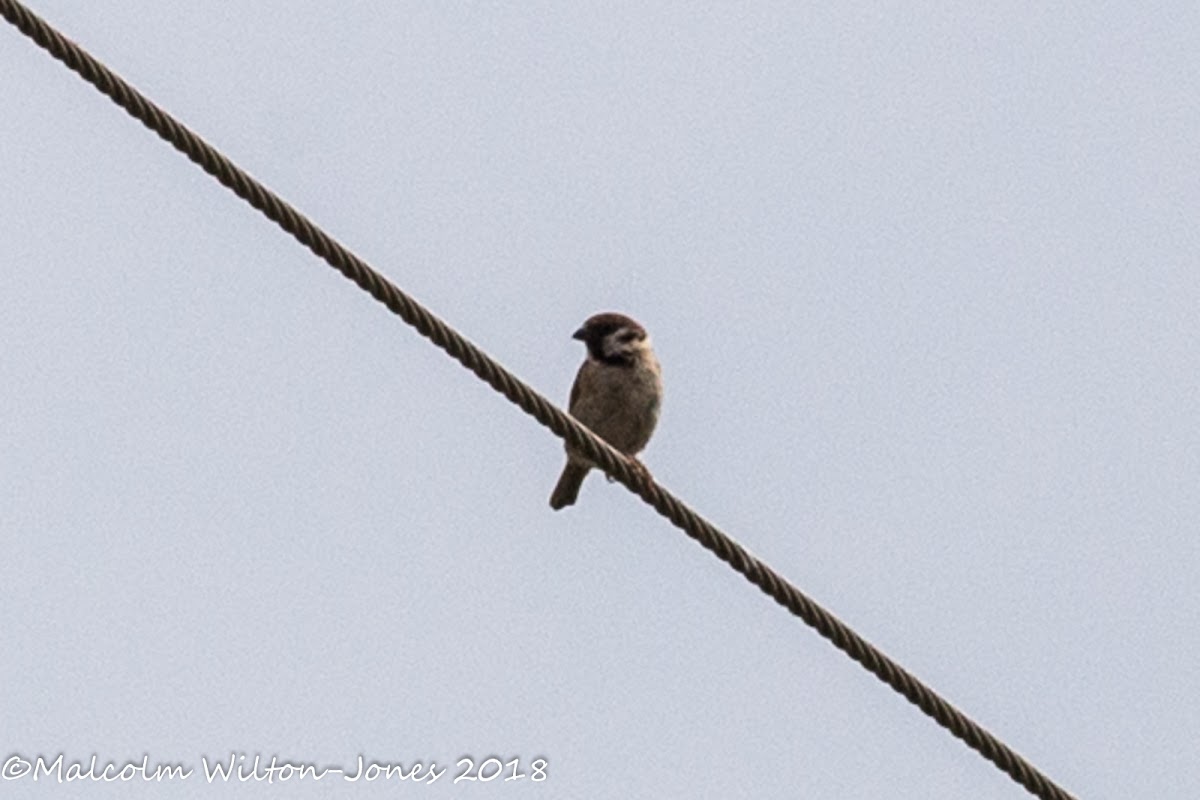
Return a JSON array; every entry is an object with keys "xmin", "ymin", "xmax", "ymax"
[{"xmin": 550, "ymin": 312, "xmax": 662, "ymax": 511}]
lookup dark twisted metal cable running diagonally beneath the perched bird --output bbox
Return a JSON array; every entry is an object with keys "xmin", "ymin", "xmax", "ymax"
[{"xmin": 0, "ymin": 0, "xmax": 1072, "ymax": 800}]
